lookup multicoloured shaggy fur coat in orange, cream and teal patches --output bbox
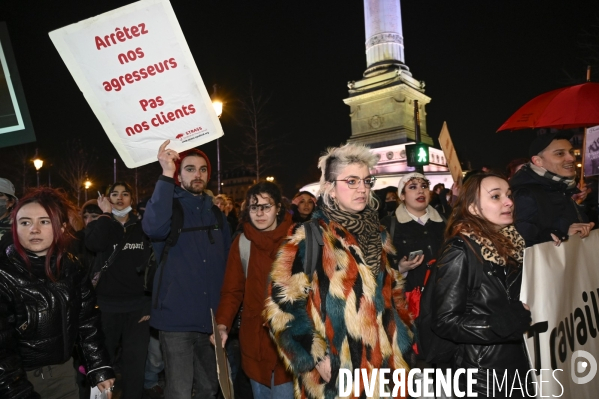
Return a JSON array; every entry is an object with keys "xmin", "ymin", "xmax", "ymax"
[{"xmin": 263, "ymin": 212, "xmax": 414, "ymax": 399}]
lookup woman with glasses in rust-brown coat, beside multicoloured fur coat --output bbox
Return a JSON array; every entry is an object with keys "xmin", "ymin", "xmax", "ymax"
[{"xmin": 215, "ymin": 182, "xmax": 293, "ymax": 399}]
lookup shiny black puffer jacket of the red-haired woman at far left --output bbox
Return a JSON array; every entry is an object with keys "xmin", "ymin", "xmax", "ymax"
[{"xmin": 0, "ymin": 245, "xmax": 114, "ymax": 397}]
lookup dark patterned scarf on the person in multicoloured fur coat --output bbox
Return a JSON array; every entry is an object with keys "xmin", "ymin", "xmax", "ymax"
[{"xmin": 321, "ymin": 203, "xmax": 383, "ymax": 275}]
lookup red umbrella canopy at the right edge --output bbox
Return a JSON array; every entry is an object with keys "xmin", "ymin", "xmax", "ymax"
[{"xmin": 497, "ymin": 82, "xmax": 599, "ymax": 132}]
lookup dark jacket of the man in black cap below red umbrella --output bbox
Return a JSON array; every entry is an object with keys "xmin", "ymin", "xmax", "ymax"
[{"xmin": 510, "ymin": 164, "xmax": 589, "ymax": 247}]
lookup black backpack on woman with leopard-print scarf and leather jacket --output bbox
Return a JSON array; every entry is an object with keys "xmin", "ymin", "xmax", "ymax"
[{"xmin": 415, "ymin": 239, "xmax": 483, "ymax": 364}]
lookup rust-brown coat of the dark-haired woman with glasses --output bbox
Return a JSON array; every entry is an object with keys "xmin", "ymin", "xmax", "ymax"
[{"xmin": 215, "ymin": 214, "xmax": 292, "ymax": 387}]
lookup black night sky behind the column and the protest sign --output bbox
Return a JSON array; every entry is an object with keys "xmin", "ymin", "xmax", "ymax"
[{"xmin": 0, "ymin": 0, "xmax": 599, "ymax": 195}]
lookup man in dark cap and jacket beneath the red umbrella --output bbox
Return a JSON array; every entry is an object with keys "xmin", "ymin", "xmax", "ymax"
[{"xmin": 510, "ymin": 131, "xmax": 594, "ymax": 247}]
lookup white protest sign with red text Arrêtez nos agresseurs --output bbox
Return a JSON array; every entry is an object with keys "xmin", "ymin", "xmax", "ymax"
[{"xmin": 50, "ymin": 0, "xmax": 223, "ymax": 168}]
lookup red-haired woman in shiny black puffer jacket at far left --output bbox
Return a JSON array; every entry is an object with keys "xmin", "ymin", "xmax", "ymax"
[{"xmin": 0, "ymin": 188, "xmax": 114, "ymax": 399}]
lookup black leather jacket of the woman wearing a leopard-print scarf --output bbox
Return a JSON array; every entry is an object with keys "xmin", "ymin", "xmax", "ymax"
[{"xmin": 432, "ymin": 237, "xmax": 530, "ymax": 395}]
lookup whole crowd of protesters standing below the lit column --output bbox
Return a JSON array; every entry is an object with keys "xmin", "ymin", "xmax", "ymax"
[{"xmin": 0, "ymin": 132, "xmax": 596, "ymax": 399}]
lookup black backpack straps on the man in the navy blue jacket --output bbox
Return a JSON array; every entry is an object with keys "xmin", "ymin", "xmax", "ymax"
[{"xmin": 152, "ymin": 198, "xmax": 224, "ymax": 309}]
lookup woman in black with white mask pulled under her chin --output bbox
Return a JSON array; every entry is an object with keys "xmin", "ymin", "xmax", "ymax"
[{"xmin": 85, "ymin": 182, "xmax": 151, "ymax": 399}]
